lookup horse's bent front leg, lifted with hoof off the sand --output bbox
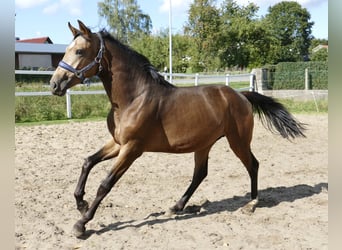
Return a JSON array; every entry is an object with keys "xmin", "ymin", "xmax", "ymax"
[{"xmin": 74, "ymin": 139, "xmax": 120, "ymax": 214}]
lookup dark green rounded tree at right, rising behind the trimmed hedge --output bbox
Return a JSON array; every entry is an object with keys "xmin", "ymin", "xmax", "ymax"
[{"xmin": 265, "ymin": 1, "xmax": 314, "ymax": 63}]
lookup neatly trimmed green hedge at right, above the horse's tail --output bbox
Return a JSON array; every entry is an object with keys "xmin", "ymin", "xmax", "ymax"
[{"xmin": 265, "ymin": 61, "xmax": 328, "ymax": 90}]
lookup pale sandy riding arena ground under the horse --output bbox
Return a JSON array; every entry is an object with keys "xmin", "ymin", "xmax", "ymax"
[{"xmin": 15, "ymin": 115, "xmax": 328, "ymax": 250}]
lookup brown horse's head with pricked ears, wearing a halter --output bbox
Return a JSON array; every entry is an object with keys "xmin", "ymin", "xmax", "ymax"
[{"xmin": 50, "ymin": 21, "xmax": 104, "ymax": 96}]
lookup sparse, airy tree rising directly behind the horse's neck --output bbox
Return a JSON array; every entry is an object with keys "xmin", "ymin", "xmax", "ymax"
[{"xmin": 98, "ymin": 0, "xmax": 152, "ymax": 44}]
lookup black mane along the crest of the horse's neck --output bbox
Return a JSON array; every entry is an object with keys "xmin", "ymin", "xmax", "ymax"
[{"xmin": 101, "ymin": 29, "xmax": 175, "ymax": 88}]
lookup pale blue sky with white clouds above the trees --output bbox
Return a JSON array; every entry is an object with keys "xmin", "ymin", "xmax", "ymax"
[{"xmin": 15, "ymin": 0, "xmax": 328, "ymax": 44}]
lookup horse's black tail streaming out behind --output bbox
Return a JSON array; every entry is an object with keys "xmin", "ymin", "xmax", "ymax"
[{"xmin": 241, "ymin": 91, "xmax": 305, "ymax": 139}]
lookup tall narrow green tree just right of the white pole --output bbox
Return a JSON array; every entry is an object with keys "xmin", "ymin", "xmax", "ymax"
[{"xmin": 184, "ymin": 0, "xmax": 220, "ymax": 72}]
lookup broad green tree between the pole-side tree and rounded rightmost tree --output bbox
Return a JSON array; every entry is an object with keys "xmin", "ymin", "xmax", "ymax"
[{"xmin": 219, "ymin": 0, "xmax": 270, "ymax": 68}]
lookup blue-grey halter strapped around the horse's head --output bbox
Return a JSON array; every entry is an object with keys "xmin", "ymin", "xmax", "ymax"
[{"xmin": 58, "ymin": 32, "xmax": 105, "ymax": 83}]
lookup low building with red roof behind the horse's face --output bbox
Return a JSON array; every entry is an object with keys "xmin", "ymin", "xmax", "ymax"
[{"xmin": 15, "ymin": 37, "xmax": 67, "ymax": 70}]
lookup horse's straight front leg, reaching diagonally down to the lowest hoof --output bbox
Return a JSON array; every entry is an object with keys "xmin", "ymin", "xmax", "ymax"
[{"xmin": 74, "ymin": 142, "xmax": 142, "ymax": 237}]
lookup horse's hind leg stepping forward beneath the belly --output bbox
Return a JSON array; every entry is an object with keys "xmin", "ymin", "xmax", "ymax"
[{"xmin": 170, "ymin": 146, "xmax": 211, "ymax": 213}]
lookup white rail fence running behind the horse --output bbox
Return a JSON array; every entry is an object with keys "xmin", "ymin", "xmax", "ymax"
[{"xmin": 15, "ymin": 70, "xmax": 255, "ymax": 119}]
